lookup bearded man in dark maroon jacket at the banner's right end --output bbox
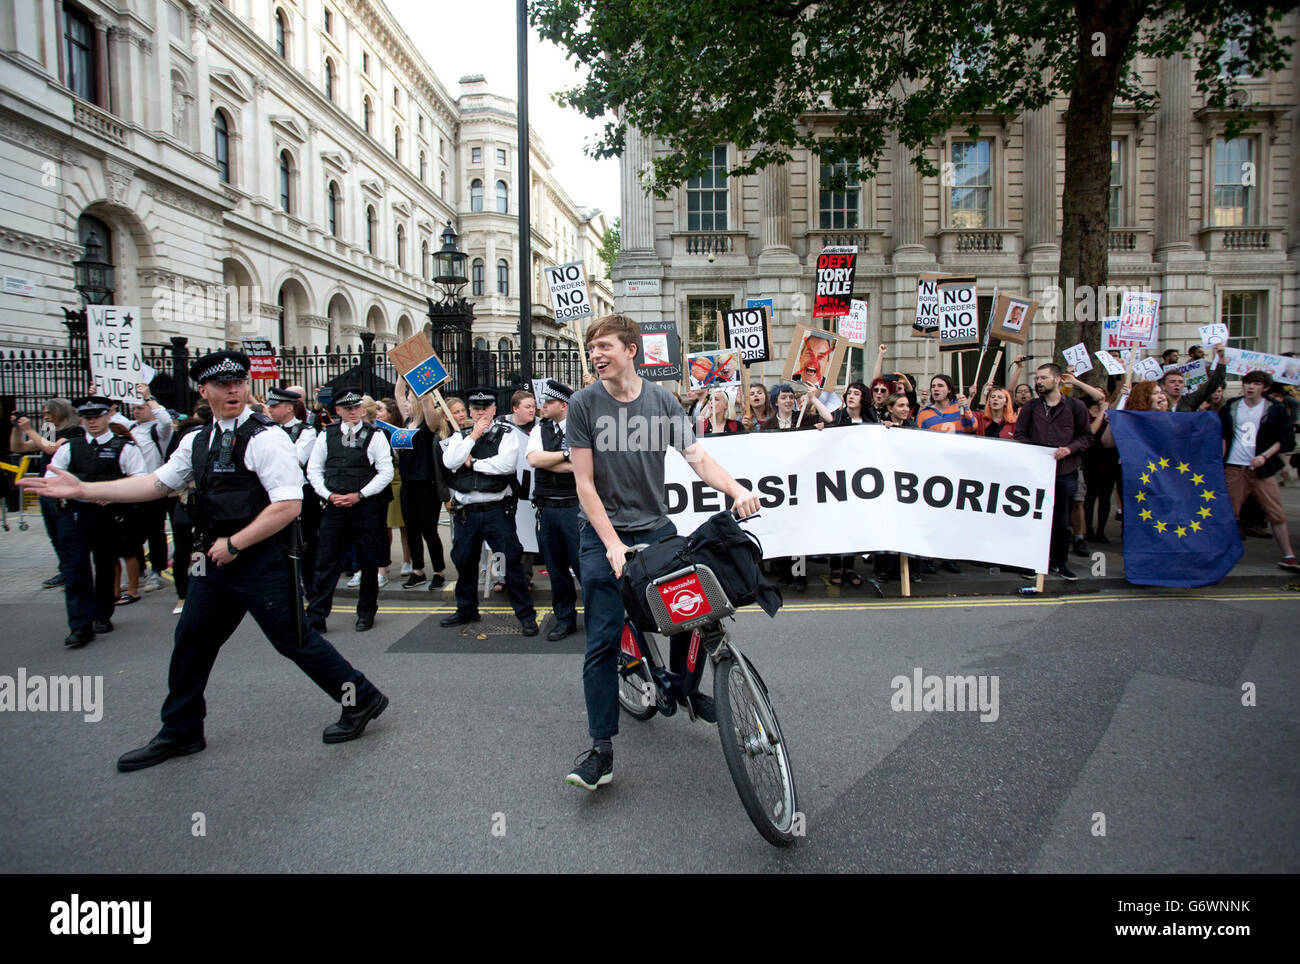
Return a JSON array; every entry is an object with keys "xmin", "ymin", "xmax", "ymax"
[{"xmin": 1015, "ymin": 362, "xmax": 1092, "ymax": 582}]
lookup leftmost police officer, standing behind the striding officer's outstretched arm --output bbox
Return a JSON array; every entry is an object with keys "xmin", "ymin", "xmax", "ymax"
[{"xmin": 46, "ymin": 395, "xmax": 146, "ymax": 647}]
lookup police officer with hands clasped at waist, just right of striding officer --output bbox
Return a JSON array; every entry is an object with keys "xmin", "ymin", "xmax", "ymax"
[{"xmin": 307, "ymin": 388, "xmax": 393, "ymax": 633}]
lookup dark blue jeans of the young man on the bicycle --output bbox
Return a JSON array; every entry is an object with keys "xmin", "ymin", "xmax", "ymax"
[{"xmin": 579, "ymin": 522, "xmax": 698, "ymax": 739}]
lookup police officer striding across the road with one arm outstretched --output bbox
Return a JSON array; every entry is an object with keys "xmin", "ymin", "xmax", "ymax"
[{"xmin": 22, "ymin": 351, "xmax": 389, "ymax": 770}]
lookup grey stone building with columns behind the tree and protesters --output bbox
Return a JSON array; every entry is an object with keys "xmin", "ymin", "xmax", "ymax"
[{"xmin": 614, "ymin": 19, "xmax": 1300, "ymax": 383}]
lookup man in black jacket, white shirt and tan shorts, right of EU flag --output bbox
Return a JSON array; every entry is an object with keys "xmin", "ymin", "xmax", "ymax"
[{"xmin": 1219, "ymin": 372, "xmax": 1300, "ymax": 572}]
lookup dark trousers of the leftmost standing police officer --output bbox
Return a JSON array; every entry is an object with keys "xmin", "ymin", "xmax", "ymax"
[{"xmin": 55, "ymin": 503, "xmax": 121, "ymax": 631}]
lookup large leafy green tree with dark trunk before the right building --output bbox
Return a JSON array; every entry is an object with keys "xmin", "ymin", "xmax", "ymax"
[{"xmin": 530, "ymin": 0, "xmax": 1295, "ymax": 377}]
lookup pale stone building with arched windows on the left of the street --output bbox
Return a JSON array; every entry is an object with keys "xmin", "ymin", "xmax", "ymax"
[{"xmin": 0, "ymin": 0, "xmax": 612, "ymax": 361}]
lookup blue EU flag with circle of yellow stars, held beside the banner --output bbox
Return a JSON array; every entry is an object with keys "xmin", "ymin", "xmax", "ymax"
[{"xmin": 1108, "ymin": 411, "xmax": 1242, "ymax": 589}]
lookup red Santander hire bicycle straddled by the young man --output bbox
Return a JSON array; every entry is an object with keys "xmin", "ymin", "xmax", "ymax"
[{"xmin": 619, "ymin": 546, "xmax": 798, "ymax": 847}]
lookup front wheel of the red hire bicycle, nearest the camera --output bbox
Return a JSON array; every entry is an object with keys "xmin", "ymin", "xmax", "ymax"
[{"xmin": 714, "ymin": 656, "xmax": 798, "ymax": 847}]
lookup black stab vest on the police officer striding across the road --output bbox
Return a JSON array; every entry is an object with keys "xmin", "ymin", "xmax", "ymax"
[{"xmin": 190, "ymin": 412, "xmax": 276, "ymax": 538}]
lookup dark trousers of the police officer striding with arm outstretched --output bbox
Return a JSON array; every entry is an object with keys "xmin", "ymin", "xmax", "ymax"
[{"xmin": 163, "ymin": 537, "xmax": 376, "ymax": 739}]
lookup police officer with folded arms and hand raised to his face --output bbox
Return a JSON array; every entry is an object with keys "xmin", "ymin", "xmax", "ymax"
[{"xmin": 439, "ymin": 388, "xmax": 537, "ymax": 637}]
